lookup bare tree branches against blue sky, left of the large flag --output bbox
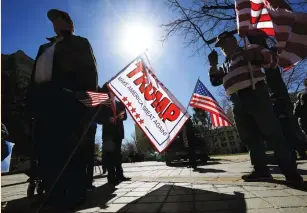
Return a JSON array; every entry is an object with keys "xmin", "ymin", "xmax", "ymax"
[{"xmin": 162, "ymin": 0, "xmax": 307, "ymax": 53}]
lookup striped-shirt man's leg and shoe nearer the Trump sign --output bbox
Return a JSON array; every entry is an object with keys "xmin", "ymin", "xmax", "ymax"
[{"xmin": 232, "ymin": 96, "xmax": 271, "ymax": 181}]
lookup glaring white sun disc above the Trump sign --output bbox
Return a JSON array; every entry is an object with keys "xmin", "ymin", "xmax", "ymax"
[{"xmin": 122, "ymin": 24, "xmax": 153, "ymax": 55}]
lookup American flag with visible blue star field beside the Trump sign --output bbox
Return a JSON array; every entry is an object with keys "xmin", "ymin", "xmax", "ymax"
[{"xmin": 190, "ymin": 80, "xmax": 231, "ymax": 127}]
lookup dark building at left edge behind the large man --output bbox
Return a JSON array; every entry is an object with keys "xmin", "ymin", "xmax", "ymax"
[{"xmin": 1, "ymin": 50, "xmax": 34, "ymax": 159}]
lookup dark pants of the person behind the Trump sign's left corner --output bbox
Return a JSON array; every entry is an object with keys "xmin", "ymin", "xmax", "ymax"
[{"xmin": 104, "ymin": 138, "xmax": 123, "ymax": 182}]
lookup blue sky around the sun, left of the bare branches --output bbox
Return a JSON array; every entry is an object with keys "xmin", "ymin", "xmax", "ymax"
[{"xmin": 1, "ymin": 0, "xmax": 220, "ymax": 143}]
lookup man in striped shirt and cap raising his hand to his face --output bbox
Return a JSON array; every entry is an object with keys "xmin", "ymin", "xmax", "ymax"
[{"xmin": 208, "ymin": 31, "xmax": 303, "ymax": 185}]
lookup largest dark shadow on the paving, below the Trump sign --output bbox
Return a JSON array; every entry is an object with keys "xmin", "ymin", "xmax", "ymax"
[{"xmin": 116, "ymin": 185, "xmax": 246, "ymax": 213}]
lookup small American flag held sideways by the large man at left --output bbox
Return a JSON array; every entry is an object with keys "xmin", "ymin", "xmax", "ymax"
[{"xmin": 76, "ymin": 91, "xmax": 110, "ymax": 107}]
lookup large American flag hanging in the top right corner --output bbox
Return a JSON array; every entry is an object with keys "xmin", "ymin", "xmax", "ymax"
[{"xmin": 235, "ymin": 0, "xmax": 307, "ymax": 70}]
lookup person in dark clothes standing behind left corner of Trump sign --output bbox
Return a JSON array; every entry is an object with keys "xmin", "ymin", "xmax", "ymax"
[{"xmin": 98, "ymin": 83, "xmax": 128, "ymax": 184}]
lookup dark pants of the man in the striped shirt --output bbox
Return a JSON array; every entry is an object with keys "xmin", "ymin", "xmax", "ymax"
[{"xmin": 231, "ymin": 82, "xmax": 296, "ymax": 175}]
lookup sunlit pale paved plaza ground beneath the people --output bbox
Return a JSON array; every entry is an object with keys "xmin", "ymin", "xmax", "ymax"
[{"xmin": 1, "ymin": 155, "xmax": 307, "ymax": 213}]
